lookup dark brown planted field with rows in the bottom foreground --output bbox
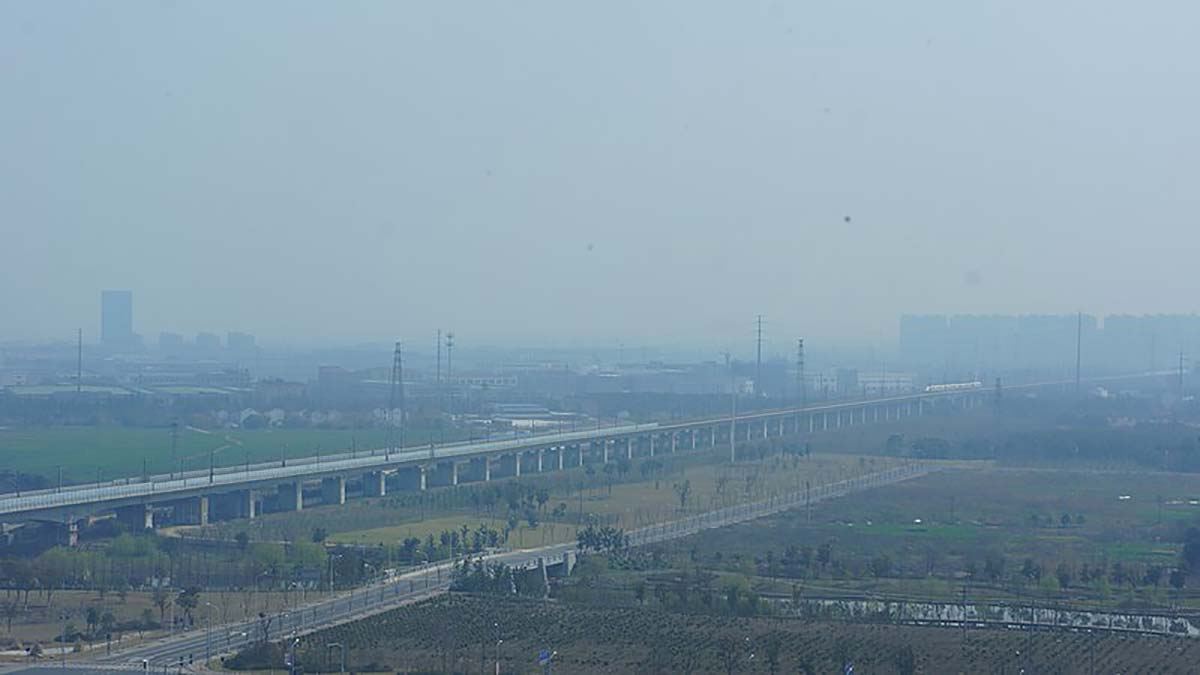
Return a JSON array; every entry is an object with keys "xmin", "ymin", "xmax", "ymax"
[{"xmin": 233, "ymin": 595, "xmax": 1200, "ymax": 674}]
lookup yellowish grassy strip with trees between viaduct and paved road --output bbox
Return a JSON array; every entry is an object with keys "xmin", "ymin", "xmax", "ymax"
[{"xmin": 194, "ymin": 453, "xmax": 902, "ymax": 548}]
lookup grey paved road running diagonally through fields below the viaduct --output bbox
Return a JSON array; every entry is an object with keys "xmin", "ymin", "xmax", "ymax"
[{"xmin": 56, "ymin": 464, "xmax": 937, "ymax": 670}]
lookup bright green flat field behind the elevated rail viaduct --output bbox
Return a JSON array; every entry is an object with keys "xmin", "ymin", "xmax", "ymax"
[{"xmin": 0, "ymin": 426, "xmax": 461, "ymax": 483}]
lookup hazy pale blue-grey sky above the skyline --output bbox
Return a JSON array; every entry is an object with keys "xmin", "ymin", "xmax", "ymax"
[{"xmin": 0, "ymin": 0, "xmax": 1200, "ymax": 353}]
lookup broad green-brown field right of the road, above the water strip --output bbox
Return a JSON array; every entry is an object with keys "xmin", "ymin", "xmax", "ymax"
[{"xmin": 654, "ymin": 468, "xmax": 1200, "ymax": 609}]
